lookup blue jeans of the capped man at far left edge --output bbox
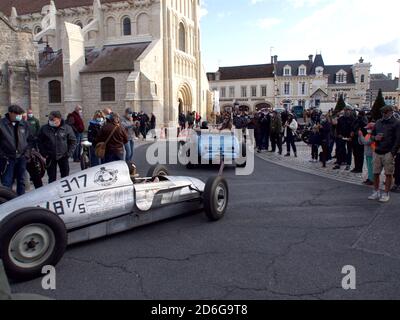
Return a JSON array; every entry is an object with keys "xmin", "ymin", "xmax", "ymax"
[{"xmin": 0, "ymin": 157, "xmax": 26, "ymax": 196}]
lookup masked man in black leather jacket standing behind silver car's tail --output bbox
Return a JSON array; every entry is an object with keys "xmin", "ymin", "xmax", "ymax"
[{"xmin": 38, "ymin": 111, "xmax": 77, "ymax": 183}]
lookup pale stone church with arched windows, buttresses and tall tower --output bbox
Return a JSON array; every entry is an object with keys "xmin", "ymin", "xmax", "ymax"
[{"xmin": 0, "ymin": 0, "xmax": 211, "ymax": 125}]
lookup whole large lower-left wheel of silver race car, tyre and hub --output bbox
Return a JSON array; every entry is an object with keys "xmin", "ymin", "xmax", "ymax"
[{"xmin": 0, "ymin": 208, "xmax": 67, "ymax": 281}]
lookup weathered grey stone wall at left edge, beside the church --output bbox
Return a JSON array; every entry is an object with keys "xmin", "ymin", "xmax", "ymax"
[{"xmin": 0, "ymin": 12, "xmax": 39, "ymax": 115}]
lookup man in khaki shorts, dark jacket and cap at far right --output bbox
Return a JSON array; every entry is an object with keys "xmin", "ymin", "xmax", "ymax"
[{"xmin": 368, "ymin": 106, "xmax": 400, "ymax": 203}]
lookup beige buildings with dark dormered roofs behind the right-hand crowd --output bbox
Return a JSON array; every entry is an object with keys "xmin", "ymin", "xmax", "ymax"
[{"xmin": 207, "ymin": 54, "xmax": 371, "ymax": 111}]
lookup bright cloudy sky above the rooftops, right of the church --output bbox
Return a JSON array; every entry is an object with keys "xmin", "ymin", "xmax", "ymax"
[{"xmin": 201, "ymin": 0, "xmax": 400, "ymax": 76}]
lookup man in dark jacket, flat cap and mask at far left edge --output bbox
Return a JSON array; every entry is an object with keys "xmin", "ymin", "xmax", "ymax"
[{"xmin": 0, "ymin": 105, "xmax": 34, "ymax": 195}]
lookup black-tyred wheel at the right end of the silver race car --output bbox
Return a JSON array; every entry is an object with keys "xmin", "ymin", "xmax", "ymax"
[{"xmin": 203, "ymin": 176, "xmax": 229, "ymax": 221}]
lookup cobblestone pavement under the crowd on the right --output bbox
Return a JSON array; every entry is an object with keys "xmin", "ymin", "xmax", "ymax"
[{"xmin": 256, "ymin": 143, "xmax": 376, "ymax": 185}]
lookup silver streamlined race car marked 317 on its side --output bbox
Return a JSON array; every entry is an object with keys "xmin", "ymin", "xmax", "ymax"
[{"xmin": 0, "ymin": 161, "xmax": 229, "ymax": 281}]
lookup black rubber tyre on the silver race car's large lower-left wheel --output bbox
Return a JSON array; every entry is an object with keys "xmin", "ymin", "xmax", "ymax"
[{"xmin": 0, "ymin": 208, "xmax": 68, "ymax": 281}]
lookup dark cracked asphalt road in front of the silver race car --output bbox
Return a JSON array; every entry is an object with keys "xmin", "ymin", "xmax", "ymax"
[{"xmin": 12, "ymin": 147, "xmax": 400, "ymax": 300}]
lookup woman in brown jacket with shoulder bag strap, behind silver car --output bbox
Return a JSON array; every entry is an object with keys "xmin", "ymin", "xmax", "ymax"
[{"xmin": 95, "ymin": 113, "xmax": 128, "ymax": 163}]
